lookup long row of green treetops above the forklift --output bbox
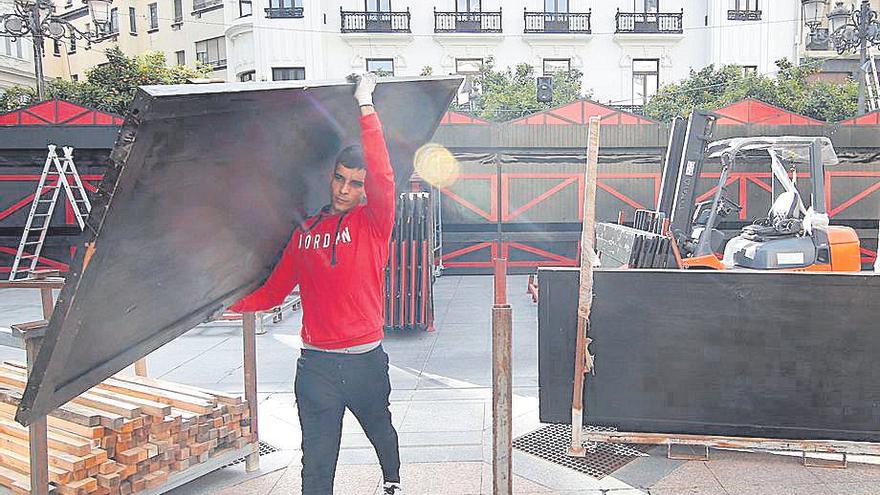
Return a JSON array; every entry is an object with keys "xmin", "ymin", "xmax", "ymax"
[{"xmin": 645, "ymin": 59, "xmax": 858, "ymax": 122}]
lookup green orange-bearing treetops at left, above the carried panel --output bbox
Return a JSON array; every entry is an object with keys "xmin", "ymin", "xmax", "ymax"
[{"xmin": 0, "ymin": 47, "xmax": 210, "ymax": 114}]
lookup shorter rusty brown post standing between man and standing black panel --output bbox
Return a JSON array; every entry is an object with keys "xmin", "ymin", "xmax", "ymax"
[{"xmin": 492, "ymin": 258, "xmax": 513, "ymax": 495}]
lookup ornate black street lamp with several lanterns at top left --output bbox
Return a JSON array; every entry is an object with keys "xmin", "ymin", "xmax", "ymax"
[{"xmin": 0, "ymin": 0, "xmax": 113, "ymax": 100}]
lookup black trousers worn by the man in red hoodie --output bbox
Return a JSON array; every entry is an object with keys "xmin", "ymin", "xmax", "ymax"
[{"xmin": 294, "ymin": 346, "xmax": 400, "ymax": 495}]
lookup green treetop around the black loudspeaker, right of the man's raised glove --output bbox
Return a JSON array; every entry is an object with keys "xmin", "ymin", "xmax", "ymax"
[{"xmin": 452, "ymin": 58, "xmax": 585, "ymax": 122}]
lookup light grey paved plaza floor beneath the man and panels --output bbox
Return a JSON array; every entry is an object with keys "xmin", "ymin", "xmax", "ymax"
[{"xmin": 0, "ymin": 277, "xmax": 880, "ymax": 495}]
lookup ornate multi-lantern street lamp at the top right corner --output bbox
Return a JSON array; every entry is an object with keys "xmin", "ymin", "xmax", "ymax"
[{"xmin": 828, "ymin": 0, "xmax": 880, "ymax": 115}]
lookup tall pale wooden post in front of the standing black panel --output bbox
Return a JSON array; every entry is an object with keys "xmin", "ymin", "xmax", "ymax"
[{"xmin": 568, "ymin": 117, "xmax": 600, "ymax": 457}]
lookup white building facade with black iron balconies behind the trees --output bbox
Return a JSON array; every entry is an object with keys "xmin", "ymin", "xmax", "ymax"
[{"xmin": 225, "ymin": 0, "xmax": 802, "ymax": 105}]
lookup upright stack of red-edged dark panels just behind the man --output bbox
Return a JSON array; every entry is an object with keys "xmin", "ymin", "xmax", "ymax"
[{"xmin": 385, "ymin": 192, "xmax": 434, "ymax": 331}]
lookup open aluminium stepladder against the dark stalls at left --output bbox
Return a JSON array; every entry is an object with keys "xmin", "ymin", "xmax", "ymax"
[{"xmin": 9, "ymin": 144, "xmax": 92, "ymax": 280}]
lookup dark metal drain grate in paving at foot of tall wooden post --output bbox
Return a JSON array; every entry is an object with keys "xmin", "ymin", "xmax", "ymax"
[{"xmin": 513, "ymin": 424, "xmax": 654, "ymax": 478}]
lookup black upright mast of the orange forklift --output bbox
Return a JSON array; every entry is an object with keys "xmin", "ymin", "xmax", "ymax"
[{"xmin": 658, "ymin": 110, "xmax": 717, "ymax": 245}]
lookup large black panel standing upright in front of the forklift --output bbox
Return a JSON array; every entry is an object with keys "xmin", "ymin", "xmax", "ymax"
[{"xmin": 538, "ymin": 268, "xmax": 880, "ymax": 442}]
